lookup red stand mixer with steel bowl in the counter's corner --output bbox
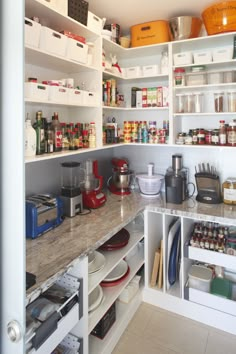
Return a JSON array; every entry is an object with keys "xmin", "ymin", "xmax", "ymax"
[{"xmin": 107, "ymin": 158, "xmax": 134, "ymax": 195}]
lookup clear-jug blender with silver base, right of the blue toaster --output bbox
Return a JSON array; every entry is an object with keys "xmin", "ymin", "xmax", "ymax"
[{"xmin": 61, "ymin": 161, "xmax": 83, "ymax": 218}]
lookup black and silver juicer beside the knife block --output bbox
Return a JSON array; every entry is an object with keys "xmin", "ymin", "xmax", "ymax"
[{"xmin": 165, "ymin": 154, "xmax": 188, "ymax": 204}]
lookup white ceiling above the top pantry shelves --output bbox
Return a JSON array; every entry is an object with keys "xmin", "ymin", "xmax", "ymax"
[{"xmin": 88, "ymin": 0, "xmax": 216, "ymax": 35}]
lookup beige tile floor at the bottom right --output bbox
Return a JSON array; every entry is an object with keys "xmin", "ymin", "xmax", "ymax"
[{"xmin": 112, "ymin": 303, "xmax": 236, "ymax": 354}]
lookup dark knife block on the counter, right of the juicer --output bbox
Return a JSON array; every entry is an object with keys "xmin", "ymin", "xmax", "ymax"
[{"xmin": 195, "ymin": 172, "xmax": 222, "ymax": 204}]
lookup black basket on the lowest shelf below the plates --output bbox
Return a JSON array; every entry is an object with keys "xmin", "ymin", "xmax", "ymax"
[{"xmin": 91, "ymin": 302, "xmax": 116, "ymax": 339}]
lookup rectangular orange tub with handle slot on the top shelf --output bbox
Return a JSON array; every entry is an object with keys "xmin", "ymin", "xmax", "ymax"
[{"xmin": 130, "ymin": 20, "xmax": 170, "ymax": 47}]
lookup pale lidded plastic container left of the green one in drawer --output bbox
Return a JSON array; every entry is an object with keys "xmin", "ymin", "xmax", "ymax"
[{"xmin": 188, "ymin": 265, "xmax": 212, "ymax": 293}]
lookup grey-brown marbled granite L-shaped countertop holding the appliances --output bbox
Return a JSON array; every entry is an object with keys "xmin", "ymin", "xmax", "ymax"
[{"xmin": 26, "ymin": 192, "xmax": 236, "ymax": 303}]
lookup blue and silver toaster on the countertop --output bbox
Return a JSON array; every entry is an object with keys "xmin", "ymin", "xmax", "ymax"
[{"xmin": 26, "ymin": 194, "xmax": 64, "ymax": 239}]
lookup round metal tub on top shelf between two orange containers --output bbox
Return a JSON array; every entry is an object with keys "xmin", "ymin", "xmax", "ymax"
[{"xmin": 169, "ymin": 16, "xmax": 202, "ymax": 41}]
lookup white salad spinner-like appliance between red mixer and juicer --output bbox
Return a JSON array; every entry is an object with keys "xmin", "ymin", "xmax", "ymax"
[{"xmin": 136, "ymin": 163, "xmax": 164, "ymax": 198}]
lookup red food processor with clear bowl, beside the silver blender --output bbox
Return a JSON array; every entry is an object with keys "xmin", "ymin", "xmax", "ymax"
[{"xmin": 81, "ymin": 160, "xmax": 107, "ymax": 209}]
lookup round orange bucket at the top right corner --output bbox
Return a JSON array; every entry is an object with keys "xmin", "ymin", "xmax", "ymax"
[{"xmin": 202, "ymin": 1, "xmax": 236, "ymax": 35}]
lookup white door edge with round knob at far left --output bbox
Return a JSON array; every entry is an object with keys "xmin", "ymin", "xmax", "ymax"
[{"xmin": 0, "ymin": 0, "xmax": 25, "ymax": 354}]
